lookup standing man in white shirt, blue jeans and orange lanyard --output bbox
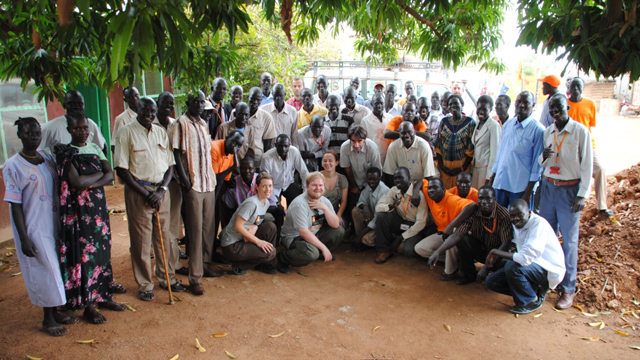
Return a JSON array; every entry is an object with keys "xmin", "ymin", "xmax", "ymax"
[{"xmin": 538, "ymin": 93, "xmax": 593, "ymax": 309}]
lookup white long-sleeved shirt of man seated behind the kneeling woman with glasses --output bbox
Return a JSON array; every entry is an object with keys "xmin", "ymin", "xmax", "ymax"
[{"xmin": 260, "ymin": 146, "xmax": 309, "ymax": 198}]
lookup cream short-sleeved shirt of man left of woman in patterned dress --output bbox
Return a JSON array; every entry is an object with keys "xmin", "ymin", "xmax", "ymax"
[{"xmin": 384, "ymin": 136, "xmax": 440, "ymax": 184}]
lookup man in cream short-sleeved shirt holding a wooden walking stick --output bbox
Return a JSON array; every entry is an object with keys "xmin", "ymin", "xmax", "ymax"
[{"xmin": 114, "ymin": 97, "xmax": 185, "ymax": 301}]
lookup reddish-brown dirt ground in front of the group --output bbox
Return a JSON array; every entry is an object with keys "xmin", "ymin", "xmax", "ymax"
[{"xmin": 0, "ymin": 184, "xmax": 640, "ymax": 359}]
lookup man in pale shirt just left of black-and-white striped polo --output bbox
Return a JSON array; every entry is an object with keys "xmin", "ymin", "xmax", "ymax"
[{"xmin": 296, "ymin": 115, "xmax": 331, "ymax": 172}]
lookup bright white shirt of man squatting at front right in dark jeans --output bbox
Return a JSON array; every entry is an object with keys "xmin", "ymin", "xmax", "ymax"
[{"xmin": 513, "ymin": 212, "xmax": 565, "ymax": 289}]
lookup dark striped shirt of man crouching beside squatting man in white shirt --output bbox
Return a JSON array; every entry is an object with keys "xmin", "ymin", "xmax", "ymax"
[{"xmin": 456, "ymin": 203, "xmax": 513, "ymax": 249}]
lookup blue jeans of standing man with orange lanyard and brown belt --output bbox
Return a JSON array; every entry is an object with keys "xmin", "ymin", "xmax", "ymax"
[{"xmin": 540, "ymin": 180, "xmax": 580, "ymax": 294}]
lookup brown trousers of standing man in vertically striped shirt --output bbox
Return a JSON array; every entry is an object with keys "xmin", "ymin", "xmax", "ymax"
[{"xmin": 182, "ymin": 190, "xmax": 216, "ymax": 285}]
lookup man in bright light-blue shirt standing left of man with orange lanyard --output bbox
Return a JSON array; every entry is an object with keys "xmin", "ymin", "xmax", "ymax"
[{"xmin": 491, "ymin": 91, "xmax": 544, "ymax": 207}]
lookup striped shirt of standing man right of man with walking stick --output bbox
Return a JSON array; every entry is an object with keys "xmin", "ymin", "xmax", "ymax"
[{"xmin": 171, "ymin": 112, "xmax": 216, "ymax": 193}]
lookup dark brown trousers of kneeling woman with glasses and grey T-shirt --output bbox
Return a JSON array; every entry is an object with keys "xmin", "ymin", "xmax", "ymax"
[{"xmin": 222, "ymin": 221, "xmax": 278, "ymax": 270}]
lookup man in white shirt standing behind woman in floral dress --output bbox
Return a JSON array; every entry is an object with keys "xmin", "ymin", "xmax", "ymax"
[{"xmin": 38, "ymin": 90, "xmax": 107, "ymax": 155}]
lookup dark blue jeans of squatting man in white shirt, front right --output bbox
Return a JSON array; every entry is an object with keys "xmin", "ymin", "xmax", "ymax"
[{"xmin": 484, "ymin": 261, "xmax": 549, "ymax": 306}]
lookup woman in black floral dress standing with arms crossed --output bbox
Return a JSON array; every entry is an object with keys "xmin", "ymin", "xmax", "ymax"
[{"xmin": 56, "ymin": 116, "xmax": 126, "ymax": 324}]
